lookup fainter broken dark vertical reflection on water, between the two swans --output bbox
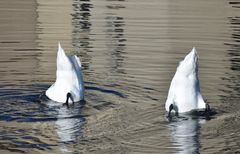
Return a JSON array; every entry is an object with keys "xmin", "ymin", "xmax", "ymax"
[{"xmin": 105, "ymin": 0, "xmax": 127, "ymax": 76}]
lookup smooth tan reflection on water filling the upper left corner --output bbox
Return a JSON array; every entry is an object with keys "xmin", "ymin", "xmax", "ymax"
[{"xmin": 0, "ymin": 0, "xmax": 39, "ymax": 85}]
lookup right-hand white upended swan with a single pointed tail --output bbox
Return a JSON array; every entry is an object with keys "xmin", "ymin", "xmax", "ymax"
[{"xmin": 165, "ymin": 48, "xmax": 210, "ymax": 116}]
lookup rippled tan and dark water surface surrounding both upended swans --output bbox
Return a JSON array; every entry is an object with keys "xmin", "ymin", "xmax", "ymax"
[{"xmin": 0, "ymin": 0, "xmax": 240, "ymax": 153}]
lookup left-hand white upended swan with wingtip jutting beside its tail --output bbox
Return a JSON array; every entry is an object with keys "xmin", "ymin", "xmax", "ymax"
[{"xmin": 45, "ymin": 43, "xmax": 84, "ymax": 105}]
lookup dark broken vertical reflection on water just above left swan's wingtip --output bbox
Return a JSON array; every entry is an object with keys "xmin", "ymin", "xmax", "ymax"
[{"xmin": 71, "ymin": 0, "xmax": 93, "ymax": 70}]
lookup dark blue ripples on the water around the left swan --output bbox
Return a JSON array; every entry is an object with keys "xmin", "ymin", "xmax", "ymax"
[{"xmin": 0, "ymin": 82, "xmax": 125, "ymax": 123}]
